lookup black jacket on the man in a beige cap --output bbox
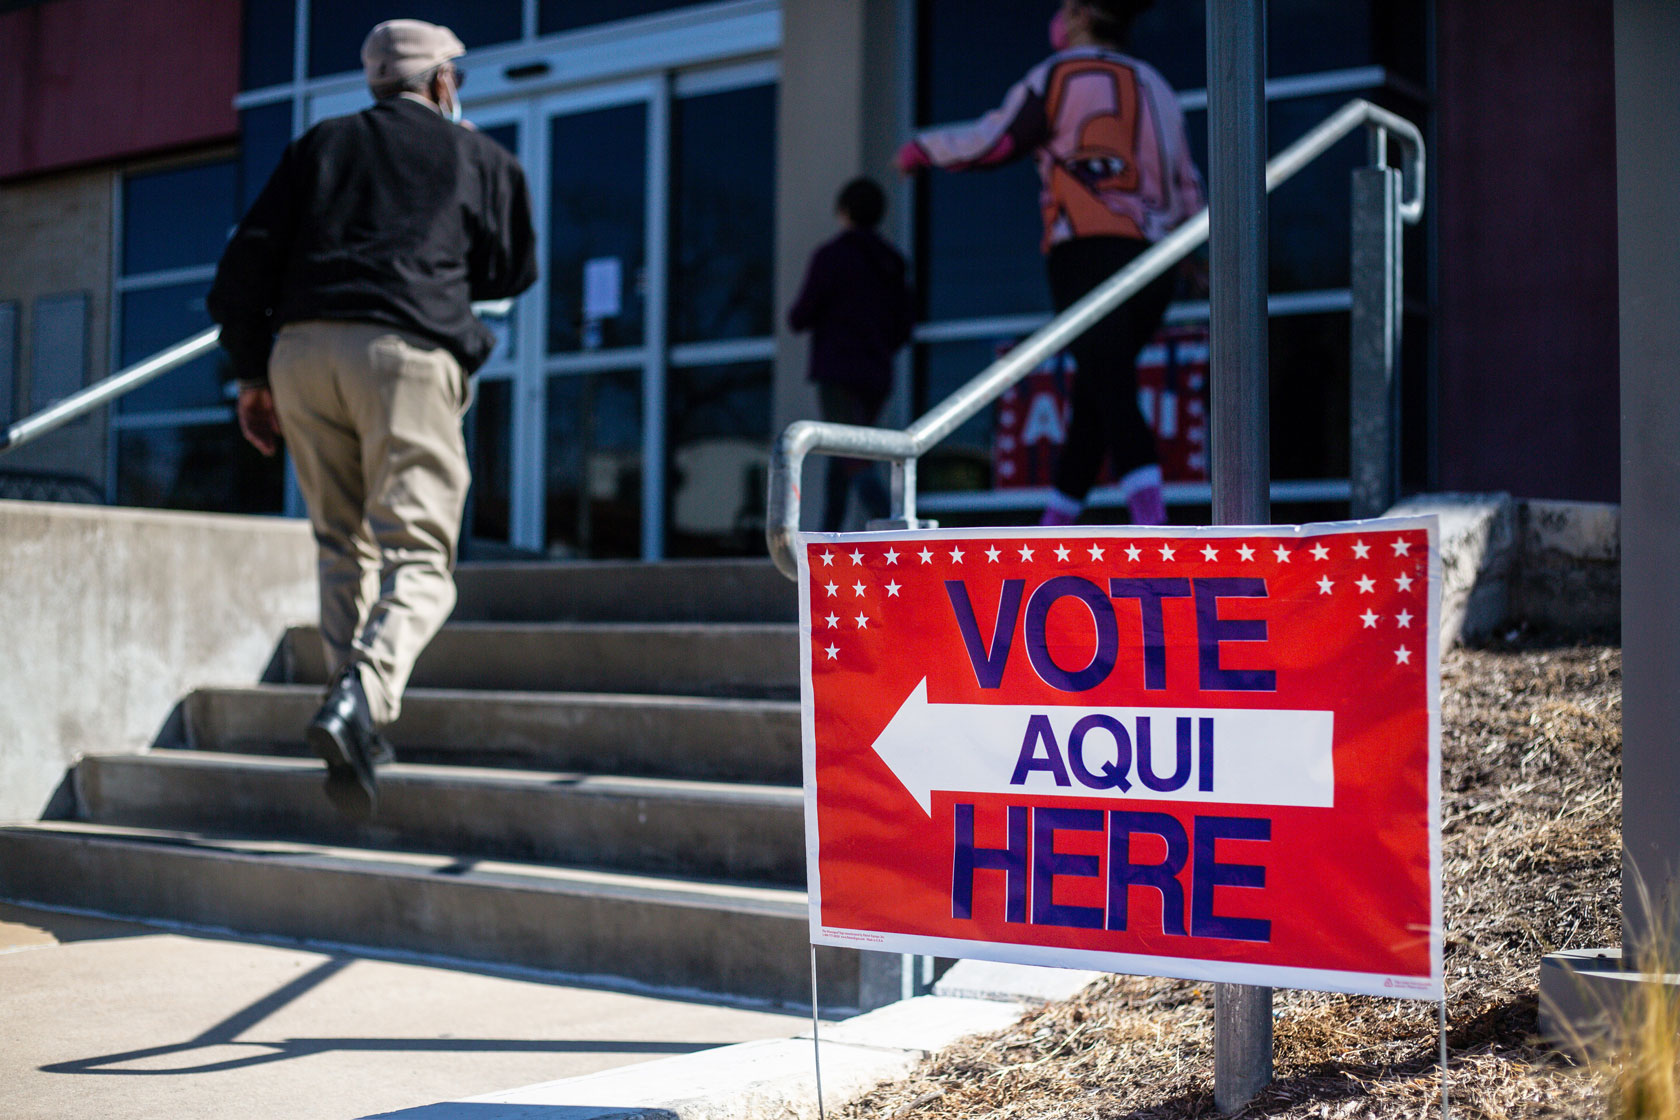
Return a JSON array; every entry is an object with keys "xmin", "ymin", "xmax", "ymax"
[{"xmin": 208, "ymin": 97, "xmax": 536, "ymax": 381}]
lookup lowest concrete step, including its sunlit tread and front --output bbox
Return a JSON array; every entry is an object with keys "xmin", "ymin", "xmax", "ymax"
[{"xmin": 0, "ymin": 821, "xmax": 877, "ymax": 1011}]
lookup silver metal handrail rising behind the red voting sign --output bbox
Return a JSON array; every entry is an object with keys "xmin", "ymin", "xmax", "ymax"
[{"xmin": 764, "ymin": 99, "xmax": 1425, "ymax": 579}]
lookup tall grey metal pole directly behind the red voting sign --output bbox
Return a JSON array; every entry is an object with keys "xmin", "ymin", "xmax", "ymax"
[{"xmin": 1208, "ymin": 0, "xmax": 1272, "ymax": 1113}]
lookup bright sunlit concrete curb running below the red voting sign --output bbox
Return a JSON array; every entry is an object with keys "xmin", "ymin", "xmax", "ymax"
[{"xmin": 363, "ymin": 960, "xmax": 1100, "ymax": 1120}]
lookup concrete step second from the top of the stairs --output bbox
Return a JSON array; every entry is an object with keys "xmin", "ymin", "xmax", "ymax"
[{"xmin": 282, "ymin": 623, "xmax": 800, "ymax": 700}]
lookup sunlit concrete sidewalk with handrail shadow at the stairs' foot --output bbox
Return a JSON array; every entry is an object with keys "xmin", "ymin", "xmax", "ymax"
[{"xmin": 0, "ymin": 905, "xmax": 810, "ymax": 1120}]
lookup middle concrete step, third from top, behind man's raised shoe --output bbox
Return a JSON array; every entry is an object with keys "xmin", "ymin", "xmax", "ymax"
[{"xmin": 177, "ymin": 685, "xmax": 801, "ymax": 786}]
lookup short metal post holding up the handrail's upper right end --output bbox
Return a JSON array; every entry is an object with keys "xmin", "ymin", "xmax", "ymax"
[{"xmin": 1347, "ymin": 166, "xmax": 1401, "ymax": 517}]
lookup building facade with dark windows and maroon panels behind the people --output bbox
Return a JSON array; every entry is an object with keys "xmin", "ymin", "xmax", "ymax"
[{"xmin": 0, "ymin": 0, "xmax": 1616, "ymax": 557}]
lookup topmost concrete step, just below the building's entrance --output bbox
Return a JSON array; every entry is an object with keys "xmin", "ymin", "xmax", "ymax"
[{"xmin": 454, "ymin": 559, "xmax": 798, "ymax": 623}]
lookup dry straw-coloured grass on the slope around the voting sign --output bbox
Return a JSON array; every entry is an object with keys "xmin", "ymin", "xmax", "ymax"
[{"xmin": 838, "ymin": 638, "xmax": 1621, "ymax": 1120}]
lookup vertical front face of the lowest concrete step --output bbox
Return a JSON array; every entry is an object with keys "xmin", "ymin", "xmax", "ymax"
[{"xmin": 0, "ymin": 831, "xmax": 858, "ymax": 1006}]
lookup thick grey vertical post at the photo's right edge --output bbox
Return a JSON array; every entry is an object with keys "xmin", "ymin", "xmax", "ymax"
[{"xmin": 1614, "ymin": 0, "xmax": 1680, "ymax": 967}]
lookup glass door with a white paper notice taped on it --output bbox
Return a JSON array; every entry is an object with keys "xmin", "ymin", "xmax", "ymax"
[{"xmin": 538, "ymin": 81, "xmax": 669, "ymax": 559}]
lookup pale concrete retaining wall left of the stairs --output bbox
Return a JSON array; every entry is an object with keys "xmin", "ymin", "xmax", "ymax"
[{"xmin": 0, "ymin": 502, "xmax": 318, "ymax": 821}]
